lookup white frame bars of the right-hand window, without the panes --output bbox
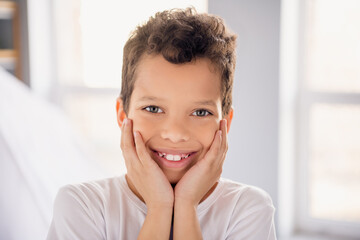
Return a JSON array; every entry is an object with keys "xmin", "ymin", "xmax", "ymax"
[{"xmin": 295, "ymin": 0, "xmax": 360, "ymax": 239}]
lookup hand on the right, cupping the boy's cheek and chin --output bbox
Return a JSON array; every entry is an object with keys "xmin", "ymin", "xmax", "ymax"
[{"xmin": 175, "ymin": 119, "xmax": 228, "ymax": 207}]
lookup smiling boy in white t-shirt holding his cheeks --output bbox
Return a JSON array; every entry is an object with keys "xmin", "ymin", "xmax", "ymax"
[{"xmin": 48, "ymin": 9, "xmax": 276, "ymax": 240}]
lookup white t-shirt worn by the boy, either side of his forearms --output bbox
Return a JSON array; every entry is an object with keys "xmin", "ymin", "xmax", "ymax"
[{"xmin": 47, "ymin": 175, "xmax": 276, "ymax": 240}]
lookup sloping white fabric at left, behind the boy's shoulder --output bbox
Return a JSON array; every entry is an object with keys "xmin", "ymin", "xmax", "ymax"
[{"xmin": 0, "ymin": 68, "xmax": 106, "ymax": 240}]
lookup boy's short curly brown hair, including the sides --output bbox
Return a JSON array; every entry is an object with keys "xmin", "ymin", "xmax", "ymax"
[{"xmin": 120, "ymin": 8, "xmax": 236, "ymax": 116}]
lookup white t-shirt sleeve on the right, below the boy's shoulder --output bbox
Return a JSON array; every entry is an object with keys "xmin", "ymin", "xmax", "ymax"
[{"xmin": 226, "ymin": 189, "xmax": 276, "ymax": 240}]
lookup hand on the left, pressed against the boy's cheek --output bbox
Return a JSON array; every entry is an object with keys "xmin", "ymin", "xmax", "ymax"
[{"xmin": 121, "ymin": 119, "xmax": 174, "ymax": 210}]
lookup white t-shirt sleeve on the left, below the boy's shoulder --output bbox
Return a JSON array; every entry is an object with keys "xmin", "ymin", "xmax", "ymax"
[{"xmin": 47, "ymin": 185, "xmax": 106, "ymax": 240}]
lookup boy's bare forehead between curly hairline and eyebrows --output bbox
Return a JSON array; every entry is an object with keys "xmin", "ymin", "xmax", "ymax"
[{"xmin": 133, "ymin": 55, "xmax": 221, "ymax": 101}]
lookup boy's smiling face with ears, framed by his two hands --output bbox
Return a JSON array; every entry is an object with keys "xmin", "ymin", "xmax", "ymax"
[{"xmin": 118, "ymin": 55, "xmax": 232, "ymax": 184}]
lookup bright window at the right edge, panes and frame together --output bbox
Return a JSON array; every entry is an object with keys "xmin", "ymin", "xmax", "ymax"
[{"xmin": 296, "ymin": 0, "xmax": 360, "ymax": 237}]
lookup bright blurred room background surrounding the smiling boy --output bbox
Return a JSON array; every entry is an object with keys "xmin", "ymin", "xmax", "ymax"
[{"xmin": 0, "ymin": 0, "xmax": 360, "ymax": 240}]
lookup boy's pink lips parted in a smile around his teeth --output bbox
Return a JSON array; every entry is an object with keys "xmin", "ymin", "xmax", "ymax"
[{"xmin": 151, "ymin": 149, "xmax": 197, "ymax": 168}]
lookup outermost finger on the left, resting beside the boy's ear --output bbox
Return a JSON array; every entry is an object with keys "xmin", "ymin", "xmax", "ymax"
[{"xmin": 121, "ymin": 119, "xmax": 138, "ymax": 167}]
